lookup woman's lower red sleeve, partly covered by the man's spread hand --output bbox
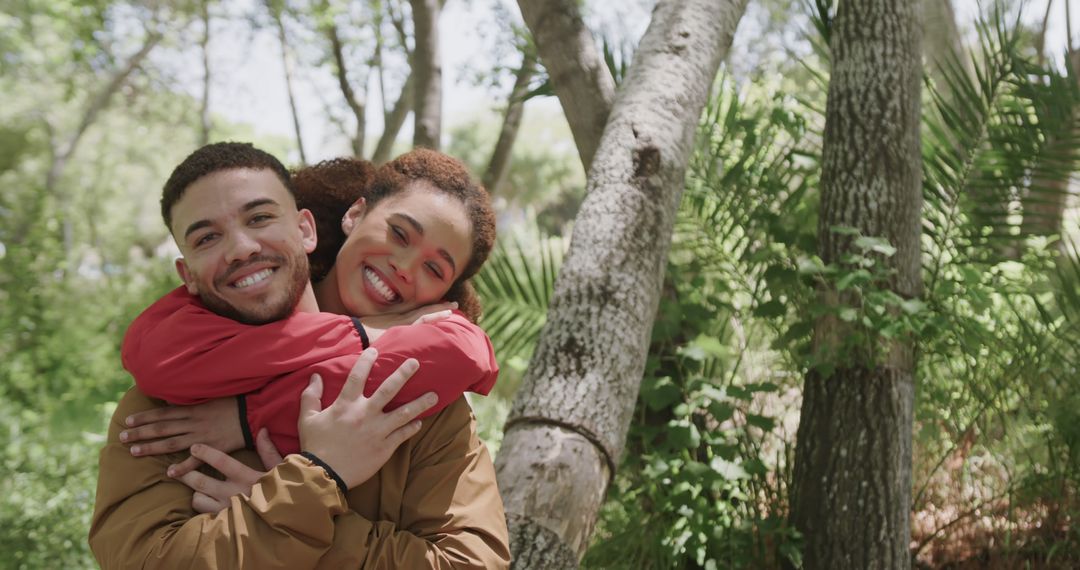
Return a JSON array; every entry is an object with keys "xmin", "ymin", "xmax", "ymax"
[{"xmin": 241, "ymin": 313, "xmax": 499, "ymax": 452}]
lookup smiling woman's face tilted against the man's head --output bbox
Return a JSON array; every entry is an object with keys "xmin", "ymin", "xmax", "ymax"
[{"xmin": 330, "ymin": 182, "xmax": 472, "ymax": 316}]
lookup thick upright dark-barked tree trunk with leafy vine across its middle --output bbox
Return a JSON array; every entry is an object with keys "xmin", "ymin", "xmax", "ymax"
[{"xmin": 792, "ymin": 0, "xmax": 922, "ymax": 570}]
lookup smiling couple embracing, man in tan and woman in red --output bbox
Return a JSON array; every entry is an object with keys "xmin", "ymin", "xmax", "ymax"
[{"xmin": 90, "ymin": 143, "xmax": 510, "ymax": 569}]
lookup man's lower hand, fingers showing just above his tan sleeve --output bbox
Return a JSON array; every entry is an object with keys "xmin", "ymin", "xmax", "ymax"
[{"xmin": 168, "ymin": 428, "xmax": 282, "ymax": 514}]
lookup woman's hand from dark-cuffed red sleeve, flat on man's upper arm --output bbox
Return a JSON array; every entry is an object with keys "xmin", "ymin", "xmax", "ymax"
[{"xmin": 120, "ymin": 397, "xmax": 244, "ymax": 457}]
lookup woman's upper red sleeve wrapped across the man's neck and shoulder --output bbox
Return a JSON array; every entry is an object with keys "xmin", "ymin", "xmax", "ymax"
[{"xmin": 121, "ymin": 287, "xmax": 363, "ymax": 405}]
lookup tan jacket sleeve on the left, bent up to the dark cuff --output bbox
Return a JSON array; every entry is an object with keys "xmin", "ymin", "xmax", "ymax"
[{"xmin": 90, "ymin": 390, "xmax": 355, "ymax": 569}]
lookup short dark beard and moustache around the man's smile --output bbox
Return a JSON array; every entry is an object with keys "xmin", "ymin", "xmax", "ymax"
[{"xmin": 199, "ymin": 253, "xmax": 310, "ymax": 325}]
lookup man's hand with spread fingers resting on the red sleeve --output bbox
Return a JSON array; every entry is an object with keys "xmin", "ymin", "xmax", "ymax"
[{"xmin": 298, "ymin": 349, "xmax": 438, "ymax": 489}]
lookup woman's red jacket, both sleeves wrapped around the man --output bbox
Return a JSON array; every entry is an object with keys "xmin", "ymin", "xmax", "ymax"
[{"xmin": 121, "ymin": 287, "xmax": 499, "ymax": 454}]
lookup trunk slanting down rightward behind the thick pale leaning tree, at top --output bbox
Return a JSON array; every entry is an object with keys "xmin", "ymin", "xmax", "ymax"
[{"xmin": 517, "ymin": 0, "xmax": 615, "ymax": 173}]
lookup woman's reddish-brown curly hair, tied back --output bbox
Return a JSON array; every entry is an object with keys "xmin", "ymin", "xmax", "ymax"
[{"xmin": 293, "ymin": 148, "xmax": 496, "ymax": 321}]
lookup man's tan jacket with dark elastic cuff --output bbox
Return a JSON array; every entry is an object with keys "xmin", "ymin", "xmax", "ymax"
[{"xmin": 90, "ymin": 389, "xmax": 510, "ymax": 570}]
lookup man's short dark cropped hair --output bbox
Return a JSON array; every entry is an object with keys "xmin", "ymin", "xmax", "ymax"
[{"xmin": 161, "ymin": 143, "xmax": 296, "ymax": 231}]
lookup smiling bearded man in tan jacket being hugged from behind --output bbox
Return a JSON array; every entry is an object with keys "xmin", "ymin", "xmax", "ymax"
[{"xmin": 90, "ymin": 144, "xmax": 509, "ymax": 568}]
